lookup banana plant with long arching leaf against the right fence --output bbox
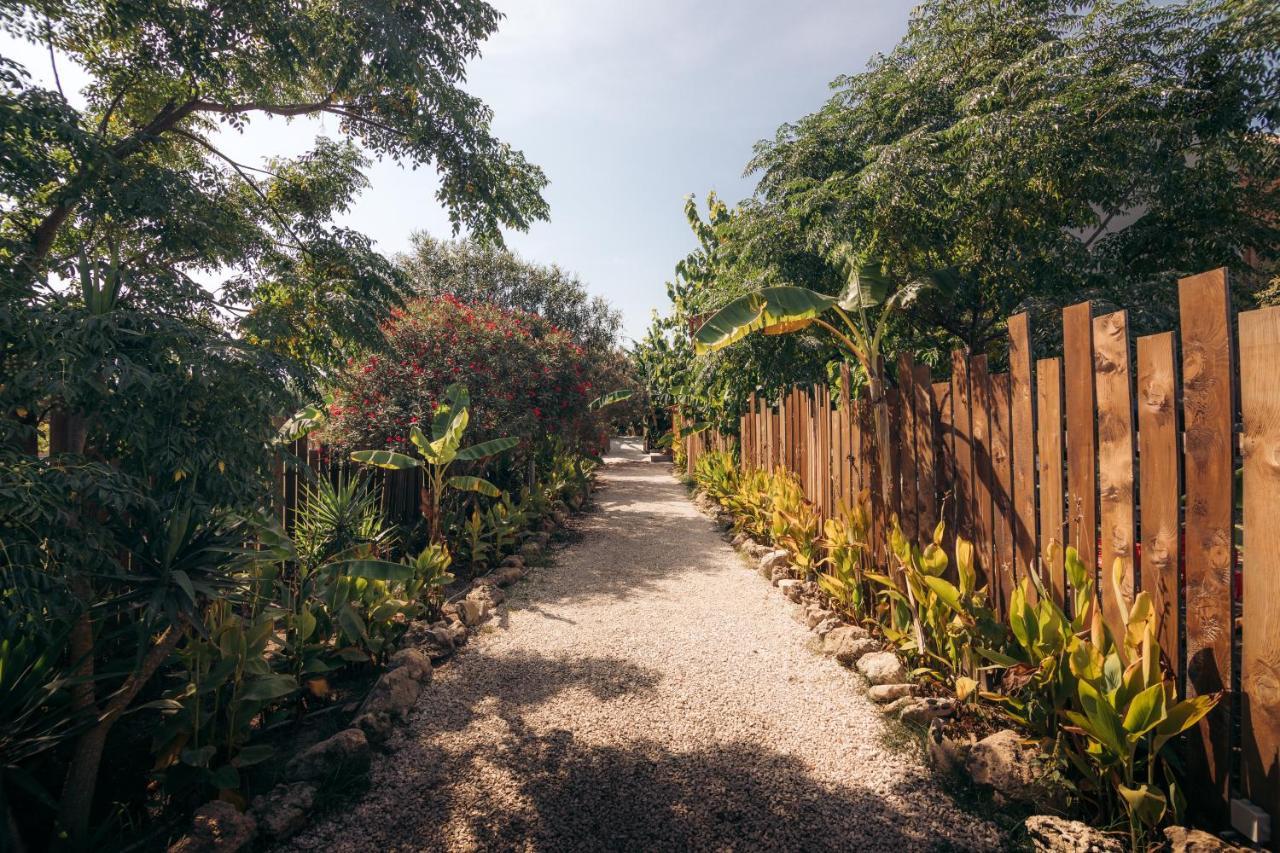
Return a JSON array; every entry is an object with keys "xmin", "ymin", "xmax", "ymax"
[{"xmin": 694, "ymin": 243, "xmax": 940, "ymax": 506}]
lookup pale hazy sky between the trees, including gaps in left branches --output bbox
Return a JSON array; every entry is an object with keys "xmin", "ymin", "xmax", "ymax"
[{"xmin": 0, "ymin": 0, "xmax": 913, "ymax": 338}]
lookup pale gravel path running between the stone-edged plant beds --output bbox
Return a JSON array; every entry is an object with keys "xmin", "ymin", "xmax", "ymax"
[{"xmin": 291, "ymin": 462, "xmax": 998, "ymax": 853}]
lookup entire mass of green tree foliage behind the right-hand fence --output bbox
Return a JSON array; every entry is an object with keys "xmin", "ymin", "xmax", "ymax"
[{"xmin": 636, "ymin": 0, "xmax": 1280, "ymax": 427}]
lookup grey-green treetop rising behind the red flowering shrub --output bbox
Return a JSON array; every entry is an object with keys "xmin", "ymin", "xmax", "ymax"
[{"xmin": 397, "ymin": 232, "xmax": 622, "ymax": 353}]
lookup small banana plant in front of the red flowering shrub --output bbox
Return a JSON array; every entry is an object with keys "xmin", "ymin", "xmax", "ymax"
[{"xmin": 351, "ymin": 384, "xmax": 520, "ymax": 543}]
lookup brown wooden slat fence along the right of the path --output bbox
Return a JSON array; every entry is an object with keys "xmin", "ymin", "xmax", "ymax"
[{"xmin": 687, "ymin": 270, "xmax": 1280, "ymax": 835}]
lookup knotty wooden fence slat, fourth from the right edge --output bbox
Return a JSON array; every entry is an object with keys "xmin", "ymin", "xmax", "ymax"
[{"xmin": 1093, "ymin": 311, "xmax": 1135, "ymax": 645}]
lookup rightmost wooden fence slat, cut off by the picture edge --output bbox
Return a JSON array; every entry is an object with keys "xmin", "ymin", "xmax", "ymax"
[{"xmin": 1239, "ymin": 307, "xmax": 1280, "ymax": 834}]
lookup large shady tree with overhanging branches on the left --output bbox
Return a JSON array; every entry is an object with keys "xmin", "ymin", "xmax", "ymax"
[{"xmin": 0, "ymin": 0, "xmax": 547, "ymax": 848}]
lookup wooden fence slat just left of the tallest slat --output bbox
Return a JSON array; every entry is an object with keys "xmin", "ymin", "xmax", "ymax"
[{"xmin": 1138, "ymin": 332, "xmax": 1184, "ymax": 689}]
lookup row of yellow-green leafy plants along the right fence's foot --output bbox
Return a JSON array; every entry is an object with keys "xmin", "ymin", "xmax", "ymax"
[{"xmin": 711, "ymin": 453, "xmax": 1219, "ymax": 850}]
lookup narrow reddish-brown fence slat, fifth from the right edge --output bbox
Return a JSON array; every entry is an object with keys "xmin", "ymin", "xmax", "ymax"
[{"xmin": 1062, "ymin": 302, "xmax": 1098, "ymax": 571}]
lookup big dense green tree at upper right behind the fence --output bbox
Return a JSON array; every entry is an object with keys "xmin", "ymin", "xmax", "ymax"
[{"xmin": 749, "ymin": 0, "xmax": 1280, "ymax": 350}]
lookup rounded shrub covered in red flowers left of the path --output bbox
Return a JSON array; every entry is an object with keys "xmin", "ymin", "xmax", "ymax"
[{"xmin": 329, "ymin": 296, "xmax": 600, "ymax": 456}]
